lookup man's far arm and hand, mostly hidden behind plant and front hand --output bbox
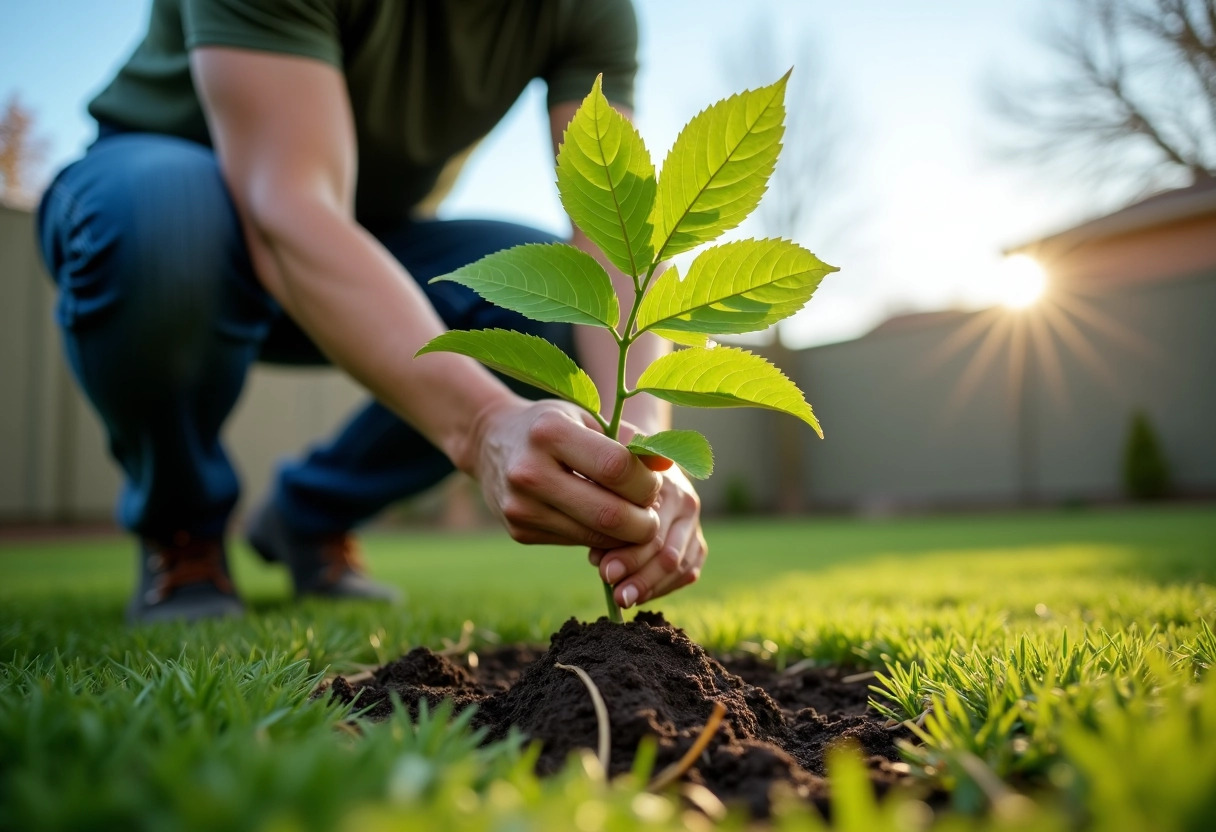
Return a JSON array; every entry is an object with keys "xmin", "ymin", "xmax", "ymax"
[{"xmin": 550, "ymin": 102, "xmax": 708, "ymax": 607}]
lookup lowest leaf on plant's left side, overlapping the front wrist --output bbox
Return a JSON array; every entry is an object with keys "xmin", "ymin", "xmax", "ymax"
[{"xmin": 417, "ymin": 330, "xmax": 599, "ymax": 414}]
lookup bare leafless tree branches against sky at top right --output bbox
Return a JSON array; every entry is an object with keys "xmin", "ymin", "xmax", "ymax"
[{"xmin": 992, "ymin": 0, "xmax": 1216, "ymax": 196}]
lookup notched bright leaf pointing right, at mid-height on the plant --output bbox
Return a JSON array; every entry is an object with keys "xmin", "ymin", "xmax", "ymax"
[{"xmin": 637, "ymin": 240, "xmax": 837, "ymax": 337}]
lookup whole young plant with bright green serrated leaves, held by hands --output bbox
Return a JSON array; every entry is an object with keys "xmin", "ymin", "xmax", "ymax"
[{"xmin": 418, "ymin": 73, "xmax": 835, "ymax": 622}]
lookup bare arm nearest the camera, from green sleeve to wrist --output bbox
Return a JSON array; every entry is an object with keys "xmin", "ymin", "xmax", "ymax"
[{"xmin": 190, "ymin": 46, "xmax": 514, "ymax": 470}]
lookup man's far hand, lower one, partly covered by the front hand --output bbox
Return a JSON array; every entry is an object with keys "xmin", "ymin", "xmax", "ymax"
[{"xmin": 590, "ymin": 467, "xmax": 708, "ymax": 607}]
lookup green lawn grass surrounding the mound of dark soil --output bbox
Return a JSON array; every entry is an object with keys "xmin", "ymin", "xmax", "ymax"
[{"xmin": 0, "ymin": 507, "xmax": 1216, "ymax": 831}]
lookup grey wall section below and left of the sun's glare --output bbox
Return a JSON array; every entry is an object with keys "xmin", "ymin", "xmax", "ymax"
[{"xmin": 796, "ymin": 319, "xmax": 1017, "ymax": 511}]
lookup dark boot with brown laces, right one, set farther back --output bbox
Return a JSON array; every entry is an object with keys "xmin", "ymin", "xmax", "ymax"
[{"xmin": 246, "ymin": 500, "xmax": 401, "ymax": 603}]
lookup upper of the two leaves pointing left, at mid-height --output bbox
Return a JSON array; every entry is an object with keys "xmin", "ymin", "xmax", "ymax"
[{"xmin": 430, "ymin": 243, "xmax": 620, "ymax": 328}]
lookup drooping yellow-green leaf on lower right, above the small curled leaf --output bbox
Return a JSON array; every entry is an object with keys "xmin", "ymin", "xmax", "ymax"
[{"xmin": 637, "ymin": 347, "xmax": 823, "ymax": 438}]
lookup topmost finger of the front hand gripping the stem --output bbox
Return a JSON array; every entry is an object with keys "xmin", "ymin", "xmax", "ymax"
[{"xmin": 530, "ymin": 414, "xmax": 663, "ymax": 506}]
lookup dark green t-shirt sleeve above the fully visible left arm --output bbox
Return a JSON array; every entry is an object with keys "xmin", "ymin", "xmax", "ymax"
[{"xmin": 181, "ymin": 0, "xmax": 342, "ymax": 69}]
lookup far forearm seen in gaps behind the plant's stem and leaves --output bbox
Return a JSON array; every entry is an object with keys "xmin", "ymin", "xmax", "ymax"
[{"xmin": 570, "ymin": 229, "xmax": 671, "ymax": 433}]
